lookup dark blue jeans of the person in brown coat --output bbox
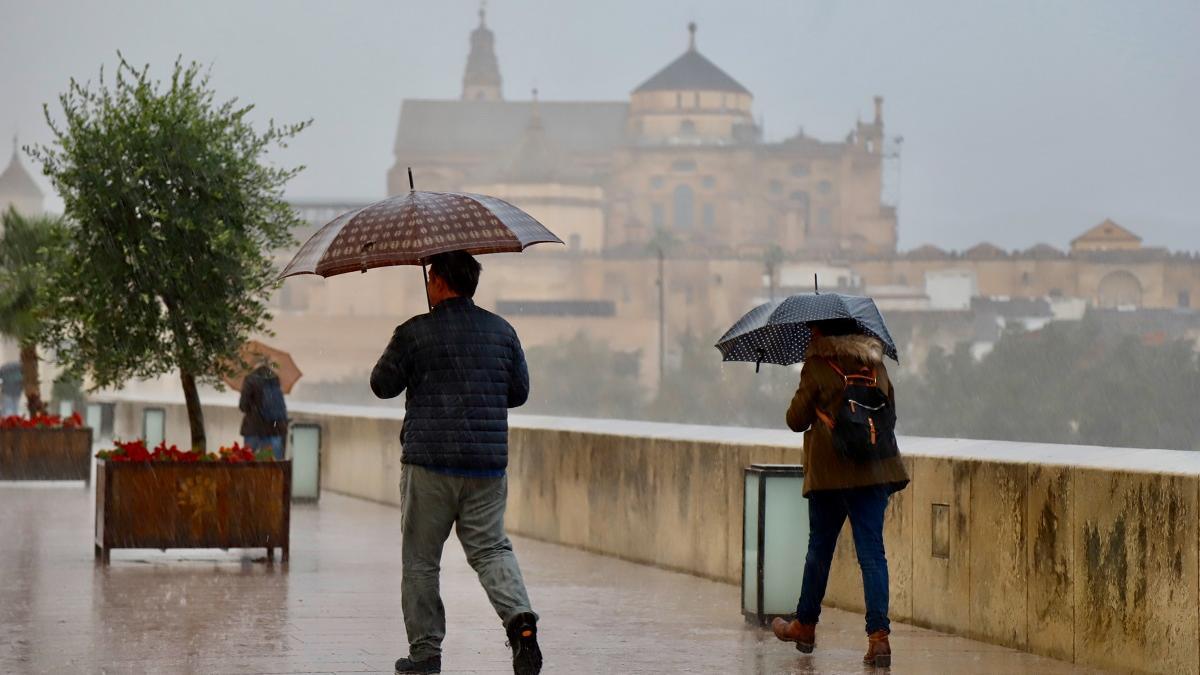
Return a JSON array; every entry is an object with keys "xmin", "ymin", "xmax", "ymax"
[{"xmin": 796, "ymin": 485, "xmax": 892, "ymax": 634}]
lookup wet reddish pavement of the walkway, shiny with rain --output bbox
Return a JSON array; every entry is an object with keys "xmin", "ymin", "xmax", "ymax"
[{"xmin": 0, "ymin": 483, "xmax": 1104, "ymax": 675}]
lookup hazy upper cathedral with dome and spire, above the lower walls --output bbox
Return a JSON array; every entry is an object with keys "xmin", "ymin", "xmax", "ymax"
[{"xmin": 388, "ymin": 12, "xmax": 896, "ymax": 257}]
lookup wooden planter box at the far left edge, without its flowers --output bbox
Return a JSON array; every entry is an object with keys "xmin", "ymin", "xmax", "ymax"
[{"xmin": 0, "ymin": 428, "xmax": 91, "ymax": 482}]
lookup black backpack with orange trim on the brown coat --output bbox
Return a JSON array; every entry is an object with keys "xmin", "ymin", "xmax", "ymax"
[{"xmin": 817, "ymin": 360, "xmax": 900, "ymax": 464}]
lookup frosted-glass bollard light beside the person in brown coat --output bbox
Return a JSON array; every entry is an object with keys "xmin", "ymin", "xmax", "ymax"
[{"xmin": 742, "ymin": 464, "xmax": 809, "ymax": 625}]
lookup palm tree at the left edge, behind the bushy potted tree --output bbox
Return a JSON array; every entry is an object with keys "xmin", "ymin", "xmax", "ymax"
[{"xmin": 0, "ymin": 208, "xmax": 62, "ymax": 414}]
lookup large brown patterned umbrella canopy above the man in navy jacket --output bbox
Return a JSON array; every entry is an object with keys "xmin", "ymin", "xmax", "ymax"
[{"xmin": 281, "ymin": 190, "xmax": 563, "ymax": 277}]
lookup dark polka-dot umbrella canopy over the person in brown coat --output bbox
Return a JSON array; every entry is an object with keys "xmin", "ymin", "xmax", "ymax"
[{"xmin": 716, "ymin": 293, "xmax": 900, "ymax": 365}]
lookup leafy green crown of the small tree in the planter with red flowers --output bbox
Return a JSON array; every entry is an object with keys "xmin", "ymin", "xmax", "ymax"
[{"xmin": 34, "ymin": 58, "xmax": 308, "ymax": 393}]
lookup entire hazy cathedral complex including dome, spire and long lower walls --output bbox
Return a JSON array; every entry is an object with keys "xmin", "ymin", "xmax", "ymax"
[{"xmin": 272, "ymin": 12, "xmax": 1200, "ymax": 390}]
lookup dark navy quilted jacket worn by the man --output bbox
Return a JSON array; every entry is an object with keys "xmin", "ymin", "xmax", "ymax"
[{"xmin": 371, "ymin": 298, "xmax": 529, "ymax": 471}]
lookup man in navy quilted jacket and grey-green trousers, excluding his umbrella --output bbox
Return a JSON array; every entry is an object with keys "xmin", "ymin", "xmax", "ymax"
[{"xmin": 371, "ymin": 251, "xmax": 541, "ymax": 675}]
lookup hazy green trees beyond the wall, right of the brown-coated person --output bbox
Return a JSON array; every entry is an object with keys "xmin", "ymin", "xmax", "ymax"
[{"xmin": 896, "ymin": 321, "xmax": 1200, "ymax": 449}]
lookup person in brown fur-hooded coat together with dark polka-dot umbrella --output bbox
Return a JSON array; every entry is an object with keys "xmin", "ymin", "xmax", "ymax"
[{"xmin": 716, "ymin": 293, "xmax": 908, "ymax": 667}]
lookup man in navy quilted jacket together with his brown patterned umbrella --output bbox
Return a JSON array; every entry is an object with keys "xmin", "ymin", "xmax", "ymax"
[{"xmin": 282, "ymin": 171, "xmax": 563, "ymax": 675}]
